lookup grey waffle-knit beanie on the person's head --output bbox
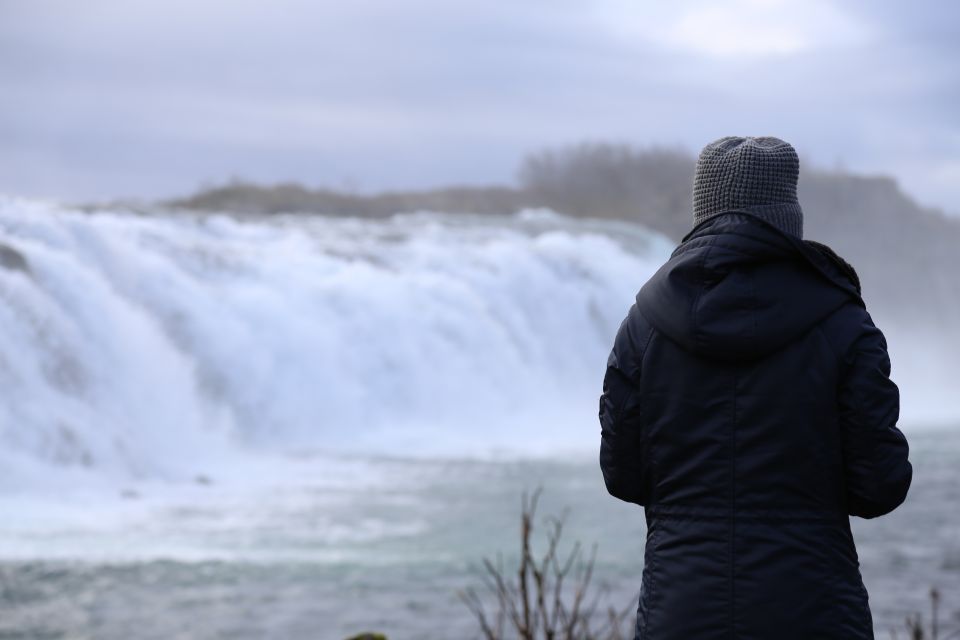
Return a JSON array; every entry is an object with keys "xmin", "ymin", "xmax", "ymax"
[{"xmin": 693, "ymin": 136, "xmax": 803, "ymax": 238}]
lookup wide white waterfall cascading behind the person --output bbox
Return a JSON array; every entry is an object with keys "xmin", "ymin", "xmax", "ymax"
[{"xmin": 0, "ymin": 199, "xmax": 956, "ymax": 490}]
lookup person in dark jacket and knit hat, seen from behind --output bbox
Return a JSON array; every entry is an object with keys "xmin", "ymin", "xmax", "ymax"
[{"xmin": 599, "ymin": 137, "xmax": 912, "ymax": 640}]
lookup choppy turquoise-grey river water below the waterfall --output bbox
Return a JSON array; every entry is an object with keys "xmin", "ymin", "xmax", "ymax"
[{"xmin": 0, "ymin": 429, "xmax": 960, "ymax": 640}]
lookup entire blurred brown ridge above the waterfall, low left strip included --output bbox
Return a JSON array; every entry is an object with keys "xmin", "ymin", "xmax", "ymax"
[{"xmin": 164, "ymin": 144, "xmax": 960, "ymax": 332}]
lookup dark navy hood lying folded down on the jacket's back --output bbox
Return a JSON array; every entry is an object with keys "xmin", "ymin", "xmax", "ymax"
[{"xmin": 636, "ymin": 212, "xmax": 864, "ymax": 361}]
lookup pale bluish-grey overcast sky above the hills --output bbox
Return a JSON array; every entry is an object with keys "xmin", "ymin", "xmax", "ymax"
[{"xmin": 0, "ymin": 0, "xmax": 960, "ymax": 214}]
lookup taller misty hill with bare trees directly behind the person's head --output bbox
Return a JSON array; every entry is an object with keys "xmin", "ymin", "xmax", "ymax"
[{"xmin": 520, "ymin": 145, "xmax": 960, "ymax": 335}]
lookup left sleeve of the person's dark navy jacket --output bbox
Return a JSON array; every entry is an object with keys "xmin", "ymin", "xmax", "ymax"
[{"xmin": 599, "ymin": 305, "xmax": 650, "ymax": 505}]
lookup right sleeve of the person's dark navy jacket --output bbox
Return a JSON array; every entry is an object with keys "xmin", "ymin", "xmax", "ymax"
[{"xmin": 839, "ymin": 313, "xmax": 913, "ymax": 518}]
